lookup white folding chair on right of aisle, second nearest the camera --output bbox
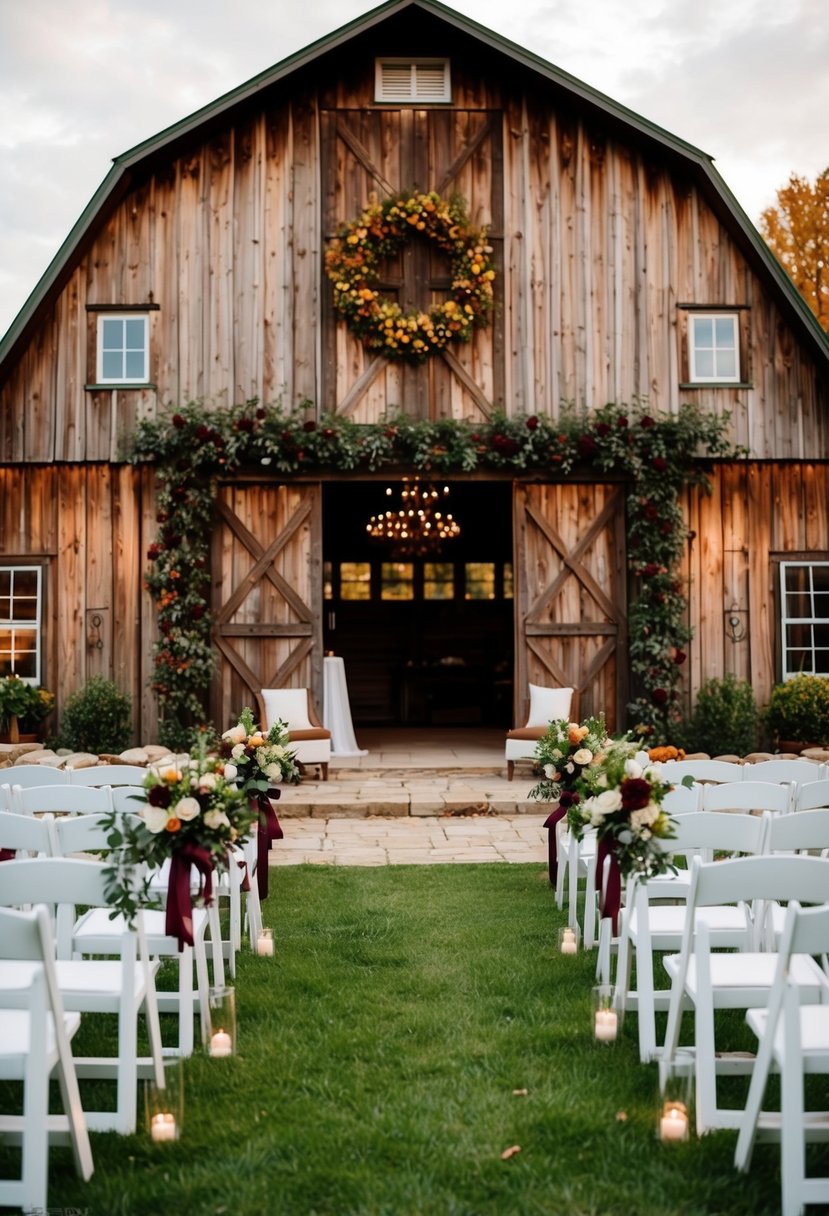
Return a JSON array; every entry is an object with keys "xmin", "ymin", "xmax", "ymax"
[{"xmin": 659, "ymin": 856, "xmax": 829, "ymax": 1136}]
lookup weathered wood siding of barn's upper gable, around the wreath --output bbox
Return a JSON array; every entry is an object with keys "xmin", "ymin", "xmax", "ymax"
[{"xmin": 0, "ymin": 28, "xmax": 829, "ymax": 462}]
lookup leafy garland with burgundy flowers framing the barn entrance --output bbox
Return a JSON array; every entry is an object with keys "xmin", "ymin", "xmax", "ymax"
[{"xmin": 131, "ymin": 400, "xmax": 740, "ymax": 747}]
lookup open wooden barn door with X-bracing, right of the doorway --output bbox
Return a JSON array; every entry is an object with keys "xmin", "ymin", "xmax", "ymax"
[{"xmin": 513, "ymin": 484, "xmax": 627, "ymax": 731}]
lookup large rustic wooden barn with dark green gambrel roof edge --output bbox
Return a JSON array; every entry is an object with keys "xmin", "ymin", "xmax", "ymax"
[{"xmin": 0, "ymin": 0, "xmax": 829, "ymax": 741}]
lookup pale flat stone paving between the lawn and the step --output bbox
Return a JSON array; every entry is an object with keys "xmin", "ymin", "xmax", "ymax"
[{"xmin": 270, "ymin": 804, "xmax": 547, "ymax": 867}]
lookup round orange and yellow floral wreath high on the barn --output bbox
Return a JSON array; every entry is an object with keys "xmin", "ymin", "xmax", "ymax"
[{"xmin": 326, "ymin": 191, "xmax": 495, "ymax": 362}]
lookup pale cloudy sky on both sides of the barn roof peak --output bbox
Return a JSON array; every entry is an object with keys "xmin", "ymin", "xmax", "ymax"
[{"xmin": 0, "ymin": 0, "xmax": 829, "ymax": 334}]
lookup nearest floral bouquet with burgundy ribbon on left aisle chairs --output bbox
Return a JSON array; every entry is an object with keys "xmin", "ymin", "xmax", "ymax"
[{"xmin": 103, "ymin": 744, "xmax": 256, "ymax": 946}]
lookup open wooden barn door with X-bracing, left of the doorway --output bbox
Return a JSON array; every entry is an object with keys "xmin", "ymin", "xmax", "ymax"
[{"xmin": 210, "ymin": 483, "xmax": 322, "ymax": 728}]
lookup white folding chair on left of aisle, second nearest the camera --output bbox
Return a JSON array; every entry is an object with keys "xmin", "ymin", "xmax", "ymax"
[{"xmin": 0, "ymin": 857, "xmax": 163, "ymax": 1135}]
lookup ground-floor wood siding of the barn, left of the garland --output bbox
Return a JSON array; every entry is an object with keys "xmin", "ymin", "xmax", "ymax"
[{"xmin": 0, "ymin": 465, "xmax": 156, "ymax": 739}]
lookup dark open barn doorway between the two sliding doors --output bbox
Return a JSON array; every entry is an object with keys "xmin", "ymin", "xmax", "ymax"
[{"xmin": 322, "ymin": 478, "xmax": 513, "ymax": 727}]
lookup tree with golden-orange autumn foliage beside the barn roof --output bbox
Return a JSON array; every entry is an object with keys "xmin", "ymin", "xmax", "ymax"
[{"xmin": 760, "ymin": 169, "xmax": 829, "ymax": 332}]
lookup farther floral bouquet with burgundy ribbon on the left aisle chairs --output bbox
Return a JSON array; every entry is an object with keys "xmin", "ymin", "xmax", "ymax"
[{"xmin": 219, "ymin": 705, "xmax": 301, "ymax": 900}]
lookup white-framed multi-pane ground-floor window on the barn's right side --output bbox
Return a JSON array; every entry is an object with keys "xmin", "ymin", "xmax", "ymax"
[{"xmin": 780, "ymin": 562, "xmax": 829, "ymax": 680}]
